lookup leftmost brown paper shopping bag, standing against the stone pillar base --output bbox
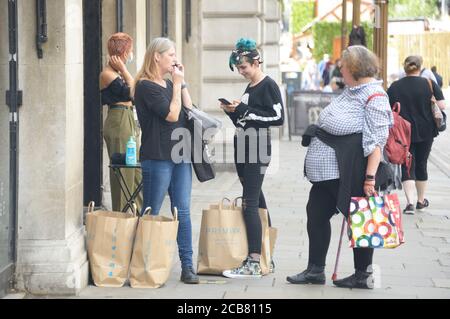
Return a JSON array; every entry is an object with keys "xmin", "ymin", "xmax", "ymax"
[{"xmin": 86, "ymin": 202, "xmax": 138, "ymax": 287}]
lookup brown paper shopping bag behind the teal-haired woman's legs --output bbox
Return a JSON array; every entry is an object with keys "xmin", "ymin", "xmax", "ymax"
[{"xmin": 197, "ymin": 199, "xmax": 248, "ymax": 275}]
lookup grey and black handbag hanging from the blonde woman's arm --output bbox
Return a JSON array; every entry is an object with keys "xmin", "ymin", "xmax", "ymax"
[{"xmin": 183, "ymin": 107, "xmax": 222, "ymax": 182}]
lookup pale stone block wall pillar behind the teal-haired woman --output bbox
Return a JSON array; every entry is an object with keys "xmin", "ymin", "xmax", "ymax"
[{"xmin": 198, "ymin": 0, "xmax": 281, "ymax": 171}]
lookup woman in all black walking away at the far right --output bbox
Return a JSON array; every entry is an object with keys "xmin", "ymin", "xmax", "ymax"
[{"xmin": 387, "ymin": 56, "xmax": 445, "ymax": 214}]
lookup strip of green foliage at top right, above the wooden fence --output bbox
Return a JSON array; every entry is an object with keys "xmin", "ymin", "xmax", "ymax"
[{"xmin": 389, "ymin": 0, "xmax": 439, "ymax": 19}]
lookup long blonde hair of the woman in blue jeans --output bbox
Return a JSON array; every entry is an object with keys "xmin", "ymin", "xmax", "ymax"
[{"xmin": 132, "ymin": 38, "xmax": 175, "ymax": 95}]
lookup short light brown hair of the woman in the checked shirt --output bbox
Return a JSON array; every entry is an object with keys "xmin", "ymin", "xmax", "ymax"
[{"xmin": 341, "ymin": 45, "xmax": 380, "ymax": 81}]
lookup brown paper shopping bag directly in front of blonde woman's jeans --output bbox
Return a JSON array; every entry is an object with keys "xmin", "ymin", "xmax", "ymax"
[{"xmin": 130, "ymin": 208, "xmax": 178, "ymax": 288}]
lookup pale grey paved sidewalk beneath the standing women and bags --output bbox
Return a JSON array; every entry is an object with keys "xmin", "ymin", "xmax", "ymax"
[{"xmin": 54, "ymin": 132, "xmax": 450, "ymax": 299}]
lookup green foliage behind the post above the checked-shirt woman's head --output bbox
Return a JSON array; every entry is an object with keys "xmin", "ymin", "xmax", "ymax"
[{"xmin": 312, "ymin": 22, "xmax": 373, "ymax": 61}]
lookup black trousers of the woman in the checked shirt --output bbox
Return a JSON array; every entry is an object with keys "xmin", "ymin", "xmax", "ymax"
[{"xmin": 306, "ymin": 179, "xmax": 373, "ymax": 271}]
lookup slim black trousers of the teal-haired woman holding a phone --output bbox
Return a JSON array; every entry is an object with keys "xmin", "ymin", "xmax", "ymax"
[{"xmin": 234, "ymin": 136, "xmax": 272, "ymax": 254}]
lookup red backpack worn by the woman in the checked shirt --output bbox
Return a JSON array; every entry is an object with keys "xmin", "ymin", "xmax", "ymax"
[{"xmin": 367, "ymin": 93, "xmax": 412, "ymax": 176}]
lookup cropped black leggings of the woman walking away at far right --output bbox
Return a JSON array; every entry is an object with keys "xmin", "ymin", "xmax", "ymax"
[{"xmin": 402, "ymin": 139, "xmax": 433, "ymax": 182}]
